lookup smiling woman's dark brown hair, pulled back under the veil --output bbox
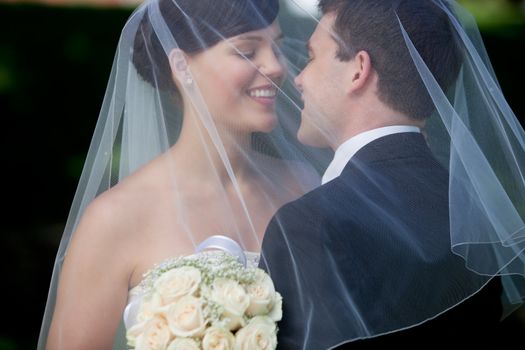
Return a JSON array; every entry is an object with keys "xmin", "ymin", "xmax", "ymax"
[{"xmin": 133, "ymin": 0, "xmax": 279, "ymax": 91}]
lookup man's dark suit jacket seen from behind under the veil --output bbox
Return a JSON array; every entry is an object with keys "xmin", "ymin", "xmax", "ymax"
[{"xmin": 260, "ymin": 133, "xmax": 501, "ymax": 350}]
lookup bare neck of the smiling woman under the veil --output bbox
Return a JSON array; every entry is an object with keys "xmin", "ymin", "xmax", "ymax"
[{"xmin": 172, "ymin": 115, "xmax": 253, "ymax": 184}]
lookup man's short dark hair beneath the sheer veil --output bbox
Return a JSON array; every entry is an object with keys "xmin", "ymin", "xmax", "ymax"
[{"xmin": 319, "ymin": 0, "xmax": 462, "ymax": 119}]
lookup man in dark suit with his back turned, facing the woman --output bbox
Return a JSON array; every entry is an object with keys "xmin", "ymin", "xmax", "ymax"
[{"xmin": 260, "ymin": 0, "xmax": 501, "ymax": 350}]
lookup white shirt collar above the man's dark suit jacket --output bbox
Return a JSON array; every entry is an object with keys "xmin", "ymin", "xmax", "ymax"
[{"xmin": 321, "ymin": 125, "xmax": 420, "ymax": 184}]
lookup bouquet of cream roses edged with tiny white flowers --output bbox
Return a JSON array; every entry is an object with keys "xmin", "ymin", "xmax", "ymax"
[{"xmin": 126, "ymin": 252, "xmax": 282, "ymax": 350}]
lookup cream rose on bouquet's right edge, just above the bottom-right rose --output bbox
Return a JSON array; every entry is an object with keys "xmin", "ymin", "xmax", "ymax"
[{"xmin": 246, "ymin": 269, "xmax": 276, "ymax": 316}]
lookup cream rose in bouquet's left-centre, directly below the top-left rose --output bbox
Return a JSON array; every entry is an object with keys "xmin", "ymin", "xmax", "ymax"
[{"xmin": 162, "ymin": 295, "xmax": 206, "ymax": 337}]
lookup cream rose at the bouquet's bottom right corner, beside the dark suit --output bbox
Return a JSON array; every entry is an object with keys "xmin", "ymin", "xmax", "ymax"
[{"xmin": 235, "ymin": 316, "xmax": 277, "ymax": 350}]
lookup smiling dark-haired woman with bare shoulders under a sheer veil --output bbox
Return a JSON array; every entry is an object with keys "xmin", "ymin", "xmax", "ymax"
[{"xmin": 39, "ymin": 0, "xmax": 319, "ymax": 349}]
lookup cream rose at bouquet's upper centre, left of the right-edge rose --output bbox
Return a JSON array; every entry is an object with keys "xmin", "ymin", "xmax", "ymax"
[{"xmin": 210, "ymin": 278, "xmax": 250, "ymax": 330}]
